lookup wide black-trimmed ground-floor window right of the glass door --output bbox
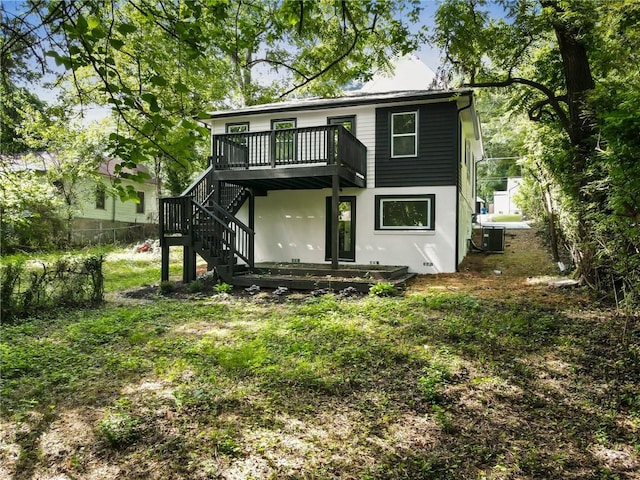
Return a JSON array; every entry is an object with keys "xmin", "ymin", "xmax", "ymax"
[{"xmin": 375, "ymin": 195, "xmax": 435, "ymax": 230}]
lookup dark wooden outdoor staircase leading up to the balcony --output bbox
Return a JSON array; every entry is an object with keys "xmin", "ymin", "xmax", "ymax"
[{"xmin": 160, "ymin": 165, "xmax": 254, "ymax": 283}]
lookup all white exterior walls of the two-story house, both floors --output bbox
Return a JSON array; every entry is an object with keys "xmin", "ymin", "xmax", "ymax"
[{"xmin": 212, "ymin": 94, "xmax": 482, "ymax": 273}]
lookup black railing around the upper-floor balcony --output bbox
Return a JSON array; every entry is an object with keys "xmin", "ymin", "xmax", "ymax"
[{"xmin": 212, "ymin": 125, "xmax": 367, "ymax": 177}]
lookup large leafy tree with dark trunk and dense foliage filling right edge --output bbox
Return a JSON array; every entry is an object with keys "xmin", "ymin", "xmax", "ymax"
[{"xmin": 432, "ymin": 0, "xmax": 640, "ymax": 301}]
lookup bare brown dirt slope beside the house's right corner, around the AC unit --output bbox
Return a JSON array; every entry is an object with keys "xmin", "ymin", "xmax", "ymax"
[{"xmin": 407, "ymin": 228, "xmax": 587, "ymax": 304}]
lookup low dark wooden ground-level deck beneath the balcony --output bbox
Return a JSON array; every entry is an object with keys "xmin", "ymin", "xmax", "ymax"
[{"xmin": 232, "ymin": 263, "xmax": 415, "ymax": 293}]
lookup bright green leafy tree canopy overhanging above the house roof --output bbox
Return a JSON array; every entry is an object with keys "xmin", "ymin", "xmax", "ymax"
[{"xmin": 0, "ymin": 0, "xmax": 419, "ymax": 201}]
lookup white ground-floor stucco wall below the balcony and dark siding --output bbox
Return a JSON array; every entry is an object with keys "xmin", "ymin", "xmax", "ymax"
[{"xmin": 238, "ymin": 187, "xmax": 456, "ymax": 273}]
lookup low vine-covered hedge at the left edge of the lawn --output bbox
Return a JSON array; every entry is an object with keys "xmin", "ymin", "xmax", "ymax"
[{"xmin": 0, "ymin": 251, "xmax": 104, "ymax": 321}]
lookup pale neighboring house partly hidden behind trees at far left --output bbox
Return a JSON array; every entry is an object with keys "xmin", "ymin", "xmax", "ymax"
[{"xmin": 3, "ymin": 152, "xmax": 158, "ymax": 244}]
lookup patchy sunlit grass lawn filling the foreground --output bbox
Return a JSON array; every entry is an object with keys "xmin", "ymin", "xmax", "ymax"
[{"xmin": 0, "ymin": 233, "xmax": 640, "ymax": 480}]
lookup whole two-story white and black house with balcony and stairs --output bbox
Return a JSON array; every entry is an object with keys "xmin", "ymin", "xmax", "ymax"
[{"xmin": 160, "ymin": 58, "xmax": 483, "ymax": 284}]
